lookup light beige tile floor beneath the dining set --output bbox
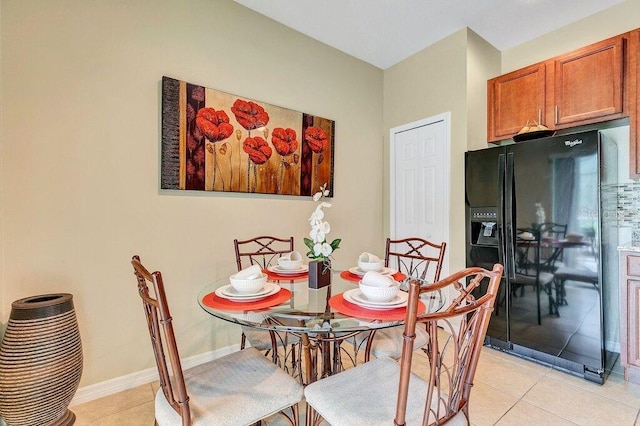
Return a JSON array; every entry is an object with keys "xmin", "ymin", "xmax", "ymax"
[{"xmin": 71, "ymin": 347, "xmax": 640, "ymax": 426}]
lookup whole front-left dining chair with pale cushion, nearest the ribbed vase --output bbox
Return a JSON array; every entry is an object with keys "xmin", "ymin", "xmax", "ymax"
[{"xmin": 131, "ymin": 255, "xmax": 303, "ymax": 426}]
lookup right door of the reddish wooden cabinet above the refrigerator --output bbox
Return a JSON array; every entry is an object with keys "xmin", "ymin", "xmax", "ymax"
[{"xmin": 553, "ymin": 36, "xmax": 625, "ymax": 127}]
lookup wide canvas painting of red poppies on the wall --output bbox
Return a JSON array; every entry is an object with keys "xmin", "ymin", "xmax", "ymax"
[{"xmin": 160, "ymin": 77, "xmax": 335, "ymax": 196}]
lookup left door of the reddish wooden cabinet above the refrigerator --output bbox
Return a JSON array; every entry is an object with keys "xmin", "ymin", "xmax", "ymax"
[{"xmin": 487, "ymin": 63, "xmax": 546, "ymax": 141}]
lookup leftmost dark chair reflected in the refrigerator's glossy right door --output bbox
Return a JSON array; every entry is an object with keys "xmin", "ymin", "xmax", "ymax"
[{"xmin": 511, "ymin": 228, "xmax": 558, "ymax": 325}]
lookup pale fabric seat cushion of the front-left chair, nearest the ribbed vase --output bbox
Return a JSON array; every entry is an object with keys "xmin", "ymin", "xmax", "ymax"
[{"xmin": 155, "ymin": 348, "xmax": 303, "ymax": 426}]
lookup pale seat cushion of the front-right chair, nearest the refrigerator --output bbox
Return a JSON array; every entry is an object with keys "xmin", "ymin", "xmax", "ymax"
[{"xmin": 304, "ymin": 358, "xmax": 467, "ymax": 426}]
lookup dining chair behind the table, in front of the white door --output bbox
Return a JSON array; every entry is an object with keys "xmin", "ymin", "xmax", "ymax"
[{"xmin": 354, "ymin": 237, "xmax": 447, "ymax": 361}]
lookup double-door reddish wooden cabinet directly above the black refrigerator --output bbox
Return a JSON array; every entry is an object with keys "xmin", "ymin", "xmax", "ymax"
[{"xmin": 487, "ymin": 33, "xmax": 630, "ymax": 142}]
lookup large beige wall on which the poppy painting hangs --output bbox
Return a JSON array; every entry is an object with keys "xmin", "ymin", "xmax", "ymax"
[{"xmin": 0, "ymin": 0, "xmax": 383, "ymax": 386}]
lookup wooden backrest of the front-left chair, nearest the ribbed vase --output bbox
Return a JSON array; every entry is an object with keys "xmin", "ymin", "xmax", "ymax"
[{"xmin": 131, "ymin": 255, "xmax": 191, "ymax": 425}]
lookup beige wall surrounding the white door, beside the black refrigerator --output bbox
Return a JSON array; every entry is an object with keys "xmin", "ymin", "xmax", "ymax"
[{"xmin": 384, "ymin": 29, "xmax": 500, "ymax": 271}]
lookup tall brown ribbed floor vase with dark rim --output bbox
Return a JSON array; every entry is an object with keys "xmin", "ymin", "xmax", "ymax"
[{"xmin": 0, "ymin": 293, "xmax": 82, "ymax": 426}]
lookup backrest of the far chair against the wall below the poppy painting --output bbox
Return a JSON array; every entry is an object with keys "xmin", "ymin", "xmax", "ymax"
[{"xmin": 233, "ymin": 236, "xmax": 293, "ymax": 271}]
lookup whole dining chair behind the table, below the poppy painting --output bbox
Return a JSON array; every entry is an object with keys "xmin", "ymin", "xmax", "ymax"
[{"xmin": 233, "ymin": 236, "xmax": 302, "ymax": 382}]
